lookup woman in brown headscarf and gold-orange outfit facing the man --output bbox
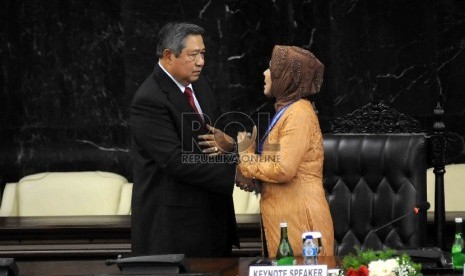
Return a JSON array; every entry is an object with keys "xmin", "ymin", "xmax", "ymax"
[{"xmin": 237, "ymin": 45, "xmax": 334, "ymax": 257}]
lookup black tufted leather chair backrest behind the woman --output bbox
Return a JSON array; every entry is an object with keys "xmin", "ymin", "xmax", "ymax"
[{"xmin": 323, "ymin": 134, "xmax": 427, "ymax": 255}]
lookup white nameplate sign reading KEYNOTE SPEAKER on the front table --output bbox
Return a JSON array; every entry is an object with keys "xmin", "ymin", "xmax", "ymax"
[{"xmin": 249, "ymin": 265, "xmax": 328, "ymax": 276}]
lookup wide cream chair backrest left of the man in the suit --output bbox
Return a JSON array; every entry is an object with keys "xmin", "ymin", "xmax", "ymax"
[{"xmin": 16, "ymin": 171, "xmax": 128, "ymax": 216}]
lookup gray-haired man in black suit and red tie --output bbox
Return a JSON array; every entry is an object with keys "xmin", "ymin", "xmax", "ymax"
[{"xmin": 130, "ymin": 23, "xmax": 238, "ymax": 257}]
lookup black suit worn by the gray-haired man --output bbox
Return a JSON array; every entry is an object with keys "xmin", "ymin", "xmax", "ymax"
[{"xmin": 130, "ymin": 65, "xmax": 238, "ymax": 257}]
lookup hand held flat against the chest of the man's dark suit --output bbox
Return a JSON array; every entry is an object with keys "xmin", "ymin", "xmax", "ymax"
[{"xmin": 199, "ymin": 124, "xmax": 235, "ymax": 155}]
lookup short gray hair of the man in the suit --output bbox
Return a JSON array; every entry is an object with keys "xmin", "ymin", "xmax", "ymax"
[{"xmin": 157, "ymin": 23, "xmax": 205, "ymax": 58}]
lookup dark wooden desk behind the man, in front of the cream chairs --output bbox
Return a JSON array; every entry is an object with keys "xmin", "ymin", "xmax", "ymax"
[{"xmin": 0, "ymin": 215, "xmax": 261, "ymax": 259}]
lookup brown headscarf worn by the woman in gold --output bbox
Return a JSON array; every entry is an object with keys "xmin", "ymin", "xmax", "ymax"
[{"xmin": 270, "ymin": 45, "xmax": 324, "ymax": 111}]
